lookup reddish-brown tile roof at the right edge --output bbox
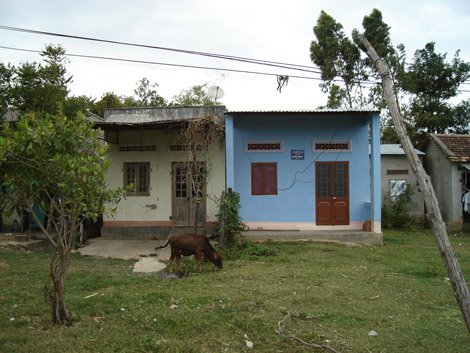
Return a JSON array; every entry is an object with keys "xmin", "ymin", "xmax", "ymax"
[{"xmin": 429, "ymin": 134, "xmax": 470, "ymax": 163}]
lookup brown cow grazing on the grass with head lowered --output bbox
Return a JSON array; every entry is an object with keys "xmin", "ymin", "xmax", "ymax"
[{"xmin": 155, "ymin": 234, "xmax": 222, "ymax": 273}]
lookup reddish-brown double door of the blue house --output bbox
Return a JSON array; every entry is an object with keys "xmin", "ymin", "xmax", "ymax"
[{"xmin": 315, "ymin": 162, "xmax": 349, "ymax": 225}]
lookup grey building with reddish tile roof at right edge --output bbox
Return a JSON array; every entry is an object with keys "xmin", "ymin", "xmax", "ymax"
[{"xmin": 424, "ymin": 134, "xmax": 470, "ymax": 230}]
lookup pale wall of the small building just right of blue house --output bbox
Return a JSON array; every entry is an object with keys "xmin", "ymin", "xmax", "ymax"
[{"xmin": 381, "ymin": 155, "xmax": 424, "ymax": 217}]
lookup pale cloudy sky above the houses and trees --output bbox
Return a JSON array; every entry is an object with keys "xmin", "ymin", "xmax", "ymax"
[{"xmin": 0, "ymin": 0, "xmax": 470, "ymax": 111}]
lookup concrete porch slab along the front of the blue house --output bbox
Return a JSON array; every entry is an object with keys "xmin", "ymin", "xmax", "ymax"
[{"xmin": 243, "ymin": 230, "xmax": 383, "ymax": 246}]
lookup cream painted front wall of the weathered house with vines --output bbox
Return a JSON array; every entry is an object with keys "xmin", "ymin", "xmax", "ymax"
[{"xmin": 104, "ymin": 130, "xmax": 225, "ymax": 225}]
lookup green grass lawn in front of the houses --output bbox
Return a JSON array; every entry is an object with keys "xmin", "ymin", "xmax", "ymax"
[{"xmin": 0, "ymin": 231, "xmax": 470, "ymax": 353}]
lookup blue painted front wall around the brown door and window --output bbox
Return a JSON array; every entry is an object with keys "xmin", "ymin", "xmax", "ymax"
[{"xmin": 226, "ymin": 113, "xmax": 380, "ymax": 222}]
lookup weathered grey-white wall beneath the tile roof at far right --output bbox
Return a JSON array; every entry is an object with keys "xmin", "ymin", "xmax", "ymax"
[{"xmin": 425, "ymin": 143, "xmax": 463, "ymax": 230}]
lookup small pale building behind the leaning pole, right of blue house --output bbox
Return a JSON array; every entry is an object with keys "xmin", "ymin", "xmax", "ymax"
[{"xmin": 380, "ymin": 144, "xmax": 424, "ymax": 217}]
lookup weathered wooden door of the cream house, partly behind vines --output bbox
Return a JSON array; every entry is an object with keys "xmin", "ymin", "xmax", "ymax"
[{"xmin": 172, "ymin": 162, "xmax": 206, "ymax": 227}]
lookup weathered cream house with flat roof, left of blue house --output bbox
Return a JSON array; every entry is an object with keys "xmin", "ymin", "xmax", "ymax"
[{"xmin": 96, "ymin": 105, "xmax": 226, "ymax": 238}]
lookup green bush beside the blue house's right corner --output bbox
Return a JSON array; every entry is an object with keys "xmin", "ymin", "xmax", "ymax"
[{"xmin": 382, "ymin": 184, "xmax": 416, "ymax": 229}]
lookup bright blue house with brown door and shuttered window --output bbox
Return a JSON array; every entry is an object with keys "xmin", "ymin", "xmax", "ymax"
[{"xmin": 225, "ymin": 110, "xmax": 382, "ymax": 244}]
